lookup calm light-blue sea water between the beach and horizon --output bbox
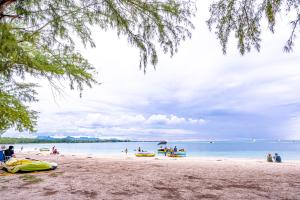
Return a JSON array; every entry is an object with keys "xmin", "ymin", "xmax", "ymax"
[{"xmin": 11, "ymin": 141, "xmax": 300, "ymax": 160}]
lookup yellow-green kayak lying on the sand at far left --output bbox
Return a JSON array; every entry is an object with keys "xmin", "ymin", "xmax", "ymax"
[{"xmin": 3, "ymin": 158, "xmax": 57, "ymax": 173}]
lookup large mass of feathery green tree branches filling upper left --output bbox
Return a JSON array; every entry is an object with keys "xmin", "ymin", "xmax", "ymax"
[{"xmin": 0, "ymin": 0, "xmax": 195, "ymax": 135}]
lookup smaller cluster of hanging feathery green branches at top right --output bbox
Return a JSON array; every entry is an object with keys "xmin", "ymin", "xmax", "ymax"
[{"xmin": 207, "ymin": 0, "xmax": 300, "ymax": 55}]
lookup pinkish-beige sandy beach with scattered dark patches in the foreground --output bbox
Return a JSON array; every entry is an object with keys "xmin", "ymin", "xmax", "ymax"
[{"xmin": 0, "ymin": 153, "xmax": 300, "ymax": 200}]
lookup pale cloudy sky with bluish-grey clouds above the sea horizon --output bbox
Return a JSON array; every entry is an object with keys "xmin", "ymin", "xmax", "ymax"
[{"xmin": 4, "ymin": 1, "xmax": 300, "ymax": 141}]
